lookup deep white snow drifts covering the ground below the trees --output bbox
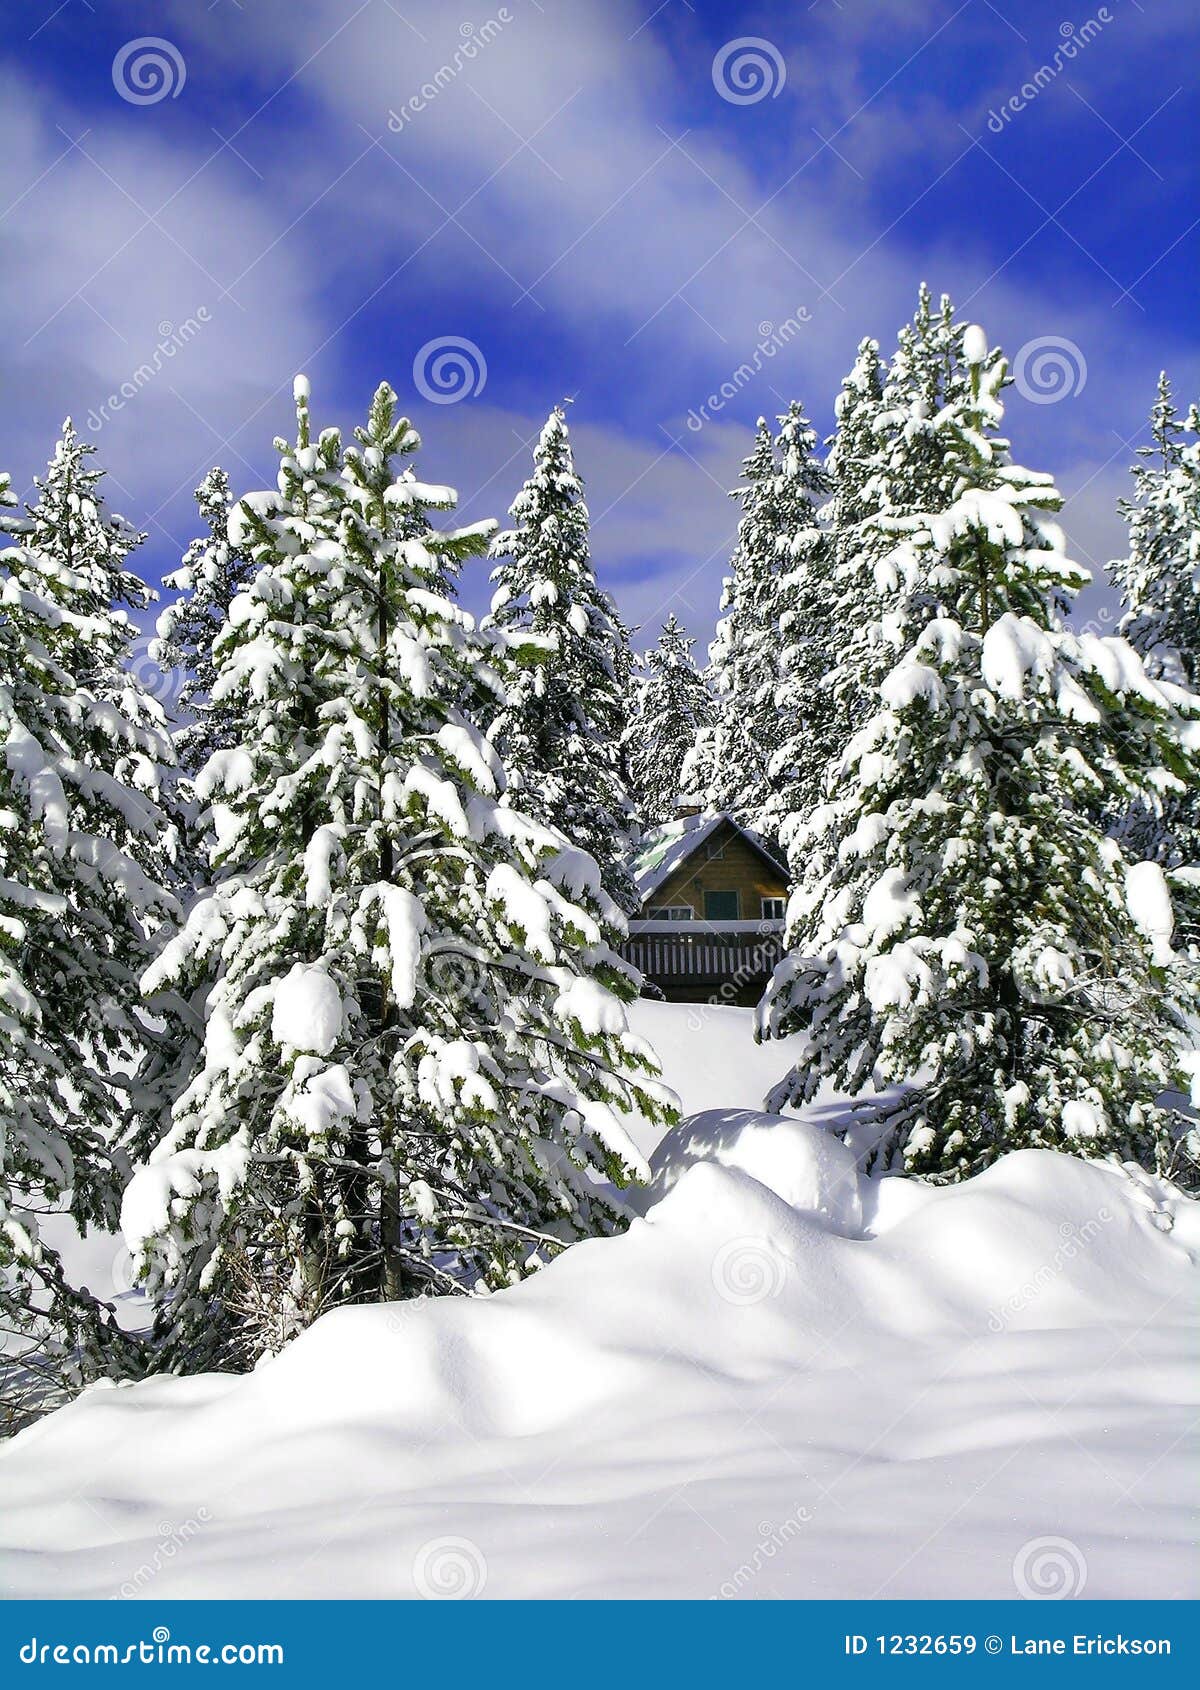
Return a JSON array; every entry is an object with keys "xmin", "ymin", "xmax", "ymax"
[{"xmin": 0, "ymin": 1006, "xmax": 1200, "ymax": 1597}]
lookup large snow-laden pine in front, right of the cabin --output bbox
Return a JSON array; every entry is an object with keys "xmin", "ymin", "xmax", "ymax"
[{"xmin": 759, "ymin": 328, "xmax": 1200, "ymax": 1180}]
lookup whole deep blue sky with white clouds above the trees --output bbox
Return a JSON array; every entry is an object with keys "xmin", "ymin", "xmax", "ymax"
[{"xmin": 0, "ymin": 0, "xmax": 1200, "ymax": 652}]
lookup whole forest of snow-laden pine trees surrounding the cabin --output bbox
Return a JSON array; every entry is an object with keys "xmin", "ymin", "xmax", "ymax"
[{"xmin": 0, "ymin": 289, "xmax": 1200, "ymax": 1418}]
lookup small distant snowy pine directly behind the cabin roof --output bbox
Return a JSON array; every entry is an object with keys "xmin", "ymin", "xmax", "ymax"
[{"xmin": 625, "ymin": 612, "xmax": 713, "ymax": 826}]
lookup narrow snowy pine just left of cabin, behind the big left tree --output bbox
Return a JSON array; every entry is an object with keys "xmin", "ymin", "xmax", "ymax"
[{"xmin": 488, "ymin": 409, "xmax": 637, "ymax": 911}]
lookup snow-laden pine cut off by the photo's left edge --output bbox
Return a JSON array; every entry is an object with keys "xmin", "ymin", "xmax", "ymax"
[{"xmin": 0, "ymin": 436, "xmax": 176, "ymax": 1412}]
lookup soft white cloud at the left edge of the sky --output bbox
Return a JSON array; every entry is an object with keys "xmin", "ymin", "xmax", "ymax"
[{"xmin": 0, "ymin": 64, "xmax": 319, "ymax": 571}]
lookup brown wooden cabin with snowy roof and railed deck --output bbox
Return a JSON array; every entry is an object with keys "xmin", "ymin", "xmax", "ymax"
[{"xmin": 625, "ymin": 813, "xmax": 788, "ymax": 1004}]
